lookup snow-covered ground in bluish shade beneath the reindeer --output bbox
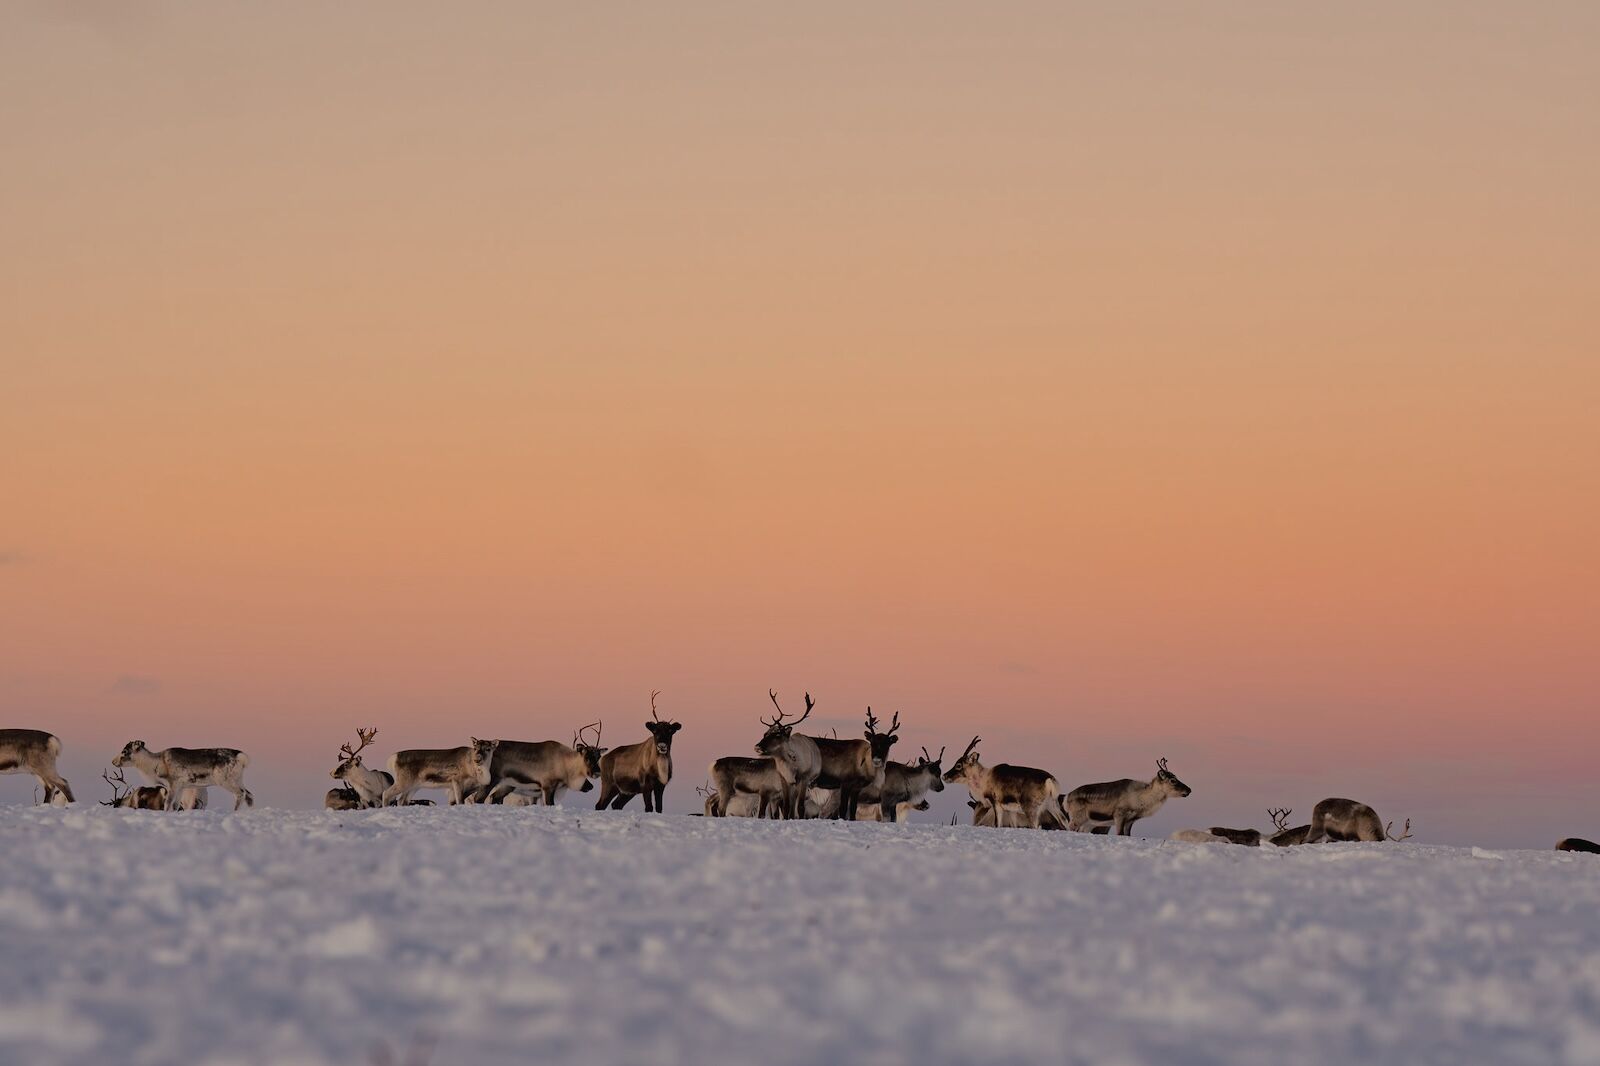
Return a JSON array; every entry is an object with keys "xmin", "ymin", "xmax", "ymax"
[{"xmin": 0, "ymin": 807, "xmax": 1600, "ymax": 1066}]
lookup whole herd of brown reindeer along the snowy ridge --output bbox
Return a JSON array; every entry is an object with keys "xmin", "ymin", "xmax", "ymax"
[{"xmin": 0, "ymin": 701, "xmax": 1600, "ymax": 852}]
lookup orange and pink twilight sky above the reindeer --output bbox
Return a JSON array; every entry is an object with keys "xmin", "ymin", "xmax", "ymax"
[{"xmin": 0, "ymin": 2, "xmax": 1600, "ymax": 847}]
